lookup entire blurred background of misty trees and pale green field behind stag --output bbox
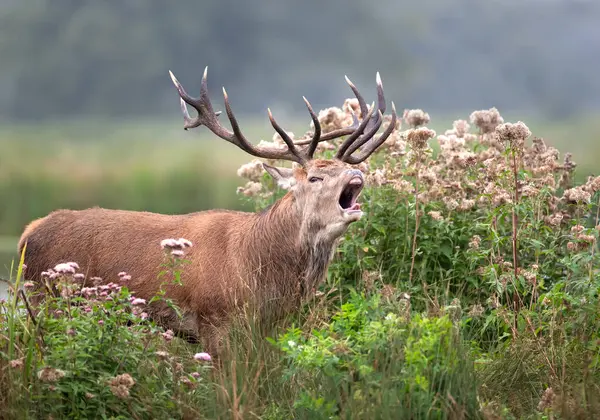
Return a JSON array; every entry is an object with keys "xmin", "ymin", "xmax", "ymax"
[{"xmin": 0, "ymin": 0, "xmax": 600, "ymax": 286}]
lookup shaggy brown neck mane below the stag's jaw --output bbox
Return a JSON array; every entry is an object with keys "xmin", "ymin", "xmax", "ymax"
[{"xmin": 246, "ymin": 193, "xmax": 335, "ymax": 295}]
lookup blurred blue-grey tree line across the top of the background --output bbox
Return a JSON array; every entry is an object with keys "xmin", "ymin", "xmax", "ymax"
[{"xmin": 0, "ymin": 0, "xmax": 600, "ymax": 120}]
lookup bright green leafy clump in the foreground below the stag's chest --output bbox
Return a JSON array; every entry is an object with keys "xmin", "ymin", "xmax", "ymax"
[{"xmin": 276, "ymin": 293, "xmax": 478, "ymax": 418}]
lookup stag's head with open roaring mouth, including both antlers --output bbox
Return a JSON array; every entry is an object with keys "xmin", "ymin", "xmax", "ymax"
[{"xmin": 169, "ymin": 69, "xmax": 397, "ymax": 240}]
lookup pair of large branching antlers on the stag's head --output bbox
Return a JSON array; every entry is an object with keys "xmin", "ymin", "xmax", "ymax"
[{"xmin": 169, "ymin": 67, "xmax": 396, "ymax": 165}]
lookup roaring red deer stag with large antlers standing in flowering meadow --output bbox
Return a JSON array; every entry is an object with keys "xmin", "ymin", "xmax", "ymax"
[{"xmin": 18, "ymin": 65, "xmax": 396, "ymax": 349}]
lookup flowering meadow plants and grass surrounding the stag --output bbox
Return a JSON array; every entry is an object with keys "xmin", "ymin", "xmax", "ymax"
[{"xmin": 0, "ymin": 104, "xmax": 600, "ymax": 419}]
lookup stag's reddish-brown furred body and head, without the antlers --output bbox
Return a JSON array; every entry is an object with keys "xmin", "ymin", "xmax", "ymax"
[{"xmin": 19, "ymin": 160, "xmax": 362, "ymax": 348}]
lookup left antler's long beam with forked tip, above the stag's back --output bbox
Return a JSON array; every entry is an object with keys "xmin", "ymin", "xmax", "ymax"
[{"xmin": 169, "ymin": 67, "xmax": 306, "ymax": 164}]
